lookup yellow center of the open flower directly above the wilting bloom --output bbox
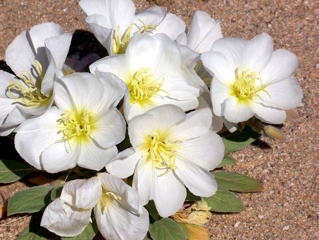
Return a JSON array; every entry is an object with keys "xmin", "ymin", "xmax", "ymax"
[{"xmin": 58, "ymin": 109, "xmax": 95, "ymax": 148}]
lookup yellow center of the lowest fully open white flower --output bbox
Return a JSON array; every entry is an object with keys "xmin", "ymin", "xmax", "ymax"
[{"xmin": 141, "ymin": 130, "xmax": 182, "ymax": 175}]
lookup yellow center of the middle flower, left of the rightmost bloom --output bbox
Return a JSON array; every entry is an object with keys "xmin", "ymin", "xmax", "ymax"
[{"xmin": 127, "ymin": 68, "xmax": 164, "ymax": 106}]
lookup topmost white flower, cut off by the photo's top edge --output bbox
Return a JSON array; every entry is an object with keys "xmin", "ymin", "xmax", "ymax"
[{"xmin": 79, "ymin": 0, "xmax": 186, "ymax": 55}]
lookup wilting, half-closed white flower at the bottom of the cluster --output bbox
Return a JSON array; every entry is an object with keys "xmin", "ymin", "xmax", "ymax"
[{"xmin": 41, "ymin": 173, "xmax": 149, "ymax": 240}]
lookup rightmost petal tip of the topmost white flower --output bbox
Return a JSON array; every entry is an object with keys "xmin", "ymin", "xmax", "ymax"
[{"xmin": 154, "ymin": 13, "xmax": 186, "ymax": 40}]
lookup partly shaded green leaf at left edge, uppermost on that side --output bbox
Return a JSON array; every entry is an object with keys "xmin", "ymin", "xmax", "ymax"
[{"xmin": 0, "ymin": 160, "xmax": 35, "ymax": 183}]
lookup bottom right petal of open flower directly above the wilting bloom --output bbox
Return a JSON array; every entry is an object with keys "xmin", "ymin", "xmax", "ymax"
[{"xmin": 78, "ymin": 141, "xmax": 118, "ymax": 171}]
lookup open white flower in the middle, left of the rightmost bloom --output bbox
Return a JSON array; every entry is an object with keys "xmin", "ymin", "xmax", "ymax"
[{"xmin": 90, "ymin": 34, "xmax": 199, "ymax": 120}]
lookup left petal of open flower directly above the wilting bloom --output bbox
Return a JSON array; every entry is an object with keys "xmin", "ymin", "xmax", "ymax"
[{"xmin": 15, "ymin": 107, "xmax": 62, "ymax": 169}]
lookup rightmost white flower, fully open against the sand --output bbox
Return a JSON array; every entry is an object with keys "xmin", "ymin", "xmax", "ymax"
[{"xmin": 201, "ymin": 33, "xmax": 302, "ymax": 124}]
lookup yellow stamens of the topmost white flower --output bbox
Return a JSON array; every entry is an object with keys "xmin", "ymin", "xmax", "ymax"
[{"xmin": 111, "ymin": 19, "xmax": 156, "ymax": 54}]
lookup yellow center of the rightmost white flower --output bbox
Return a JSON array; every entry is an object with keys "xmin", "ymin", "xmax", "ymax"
[{"xmin": 232, "ymin": 67, "xmax": 271, "ymax": 102}]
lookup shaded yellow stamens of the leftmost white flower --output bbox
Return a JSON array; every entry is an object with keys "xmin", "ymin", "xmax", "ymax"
[{"xmin": 8, "ymin": 60, "xmax": 50, "ymax": 107}]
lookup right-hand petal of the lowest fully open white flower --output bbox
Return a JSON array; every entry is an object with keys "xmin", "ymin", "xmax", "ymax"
[{"xmin": 178, "ymin": 131, "xmax": 225, "ymax": 171}]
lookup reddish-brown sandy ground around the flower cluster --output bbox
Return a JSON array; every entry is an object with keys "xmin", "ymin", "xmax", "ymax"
[{"xmin": 0, "ymin": 0, "xmax": 319, "ymax": 240}]
